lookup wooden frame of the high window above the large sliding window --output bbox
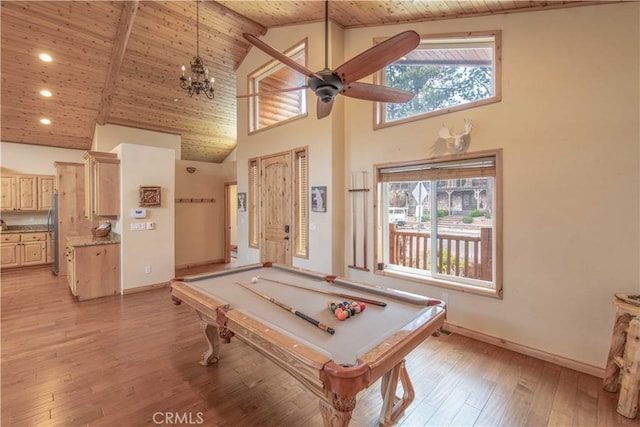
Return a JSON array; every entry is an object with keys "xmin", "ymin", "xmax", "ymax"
[{"xmin": 373, "ymin": 30, "xmax": 502, "ymax": 130}]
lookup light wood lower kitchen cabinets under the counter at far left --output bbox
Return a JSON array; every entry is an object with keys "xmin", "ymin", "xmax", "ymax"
[{"xmin": 0, "ymin": 232, "xmax": 49, "ymax": 269}]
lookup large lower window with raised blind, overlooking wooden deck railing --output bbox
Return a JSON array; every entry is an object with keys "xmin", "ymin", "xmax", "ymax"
[{"xmin": 376, "ymin": 150, "xmax": 502, "ymax": 297}]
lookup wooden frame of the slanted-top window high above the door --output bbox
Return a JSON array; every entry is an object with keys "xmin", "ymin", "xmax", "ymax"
[{"xmin": 247, "ymin": 38, "xmax": 309, "ymax": 135}]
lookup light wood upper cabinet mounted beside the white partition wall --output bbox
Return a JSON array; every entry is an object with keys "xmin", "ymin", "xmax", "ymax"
[{"xmin": 84, "ymin": 151, "xmax": 120, "ymax": 218}]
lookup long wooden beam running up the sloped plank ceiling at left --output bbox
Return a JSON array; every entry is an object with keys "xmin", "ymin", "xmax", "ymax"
[{"xmin": 96, "ymin": 0, "xmax": 139, "ymax": 125}]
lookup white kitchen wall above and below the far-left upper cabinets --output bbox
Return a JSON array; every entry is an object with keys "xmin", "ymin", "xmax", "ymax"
[{"xmin": 0, "ymin": 142, "xmax": 85, "ymax": 225}]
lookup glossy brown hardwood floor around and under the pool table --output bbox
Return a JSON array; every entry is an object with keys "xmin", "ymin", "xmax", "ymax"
[{"xmin": 1, "ymin": 268, "xmax": 640, "ymax": 427}]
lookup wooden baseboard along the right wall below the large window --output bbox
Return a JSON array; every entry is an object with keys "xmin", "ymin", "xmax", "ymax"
[{"xmin": 443, "ymin": 322, "xmax": 604, "ymax": 378}]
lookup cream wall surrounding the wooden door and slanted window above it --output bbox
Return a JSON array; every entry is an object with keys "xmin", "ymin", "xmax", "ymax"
[{"xmin": 236, "ymin": 23, "xmax": 344, "ymax": 271}]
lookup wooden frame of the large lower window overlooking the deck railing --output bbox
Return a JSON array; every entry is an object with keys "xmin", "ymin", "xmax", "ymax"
[{"xmin": 374, "ymin": 149, "xmax": 503, "ymax": 299}]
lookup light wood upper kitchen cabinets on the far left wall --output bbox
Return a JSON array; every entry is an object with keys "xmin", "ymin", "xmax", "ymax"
[{"xmin": 0, "ymin": 175, "xmax": 54, "ymax": 211}]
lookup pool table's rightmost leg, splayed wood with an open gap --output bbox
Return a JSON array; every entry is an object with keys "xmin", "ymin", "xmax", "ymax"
[{"xmin": 380, "ymin": 360, "xmax": 415, "ymax": 426}]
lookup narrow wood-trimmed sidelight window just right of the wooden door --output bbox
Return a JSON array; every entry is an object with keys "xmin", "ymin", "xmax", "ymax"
[{"xmin": 294, "ymin": 148, "xmax": 309, "ymax": 258}]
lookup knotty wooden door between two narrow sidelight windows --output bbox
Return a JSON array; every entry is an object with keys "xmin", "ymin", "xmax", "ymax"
[{"xmin": 260, "ymin": 153, "xmax": 292, "ymax": 265}]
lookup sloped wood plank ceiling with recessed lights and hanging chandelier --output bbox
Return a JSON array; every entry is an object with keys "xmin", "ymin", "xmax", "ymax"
[{"xmin": 0, "ymin": 0, "xmax": 602, "ymax": 162}]
